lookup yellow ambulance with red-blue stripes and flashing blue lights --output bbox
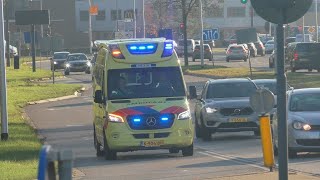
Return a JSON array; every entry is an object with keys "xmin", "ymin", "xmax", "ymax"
[{"xmin": 93, "ymin": 38, "xmax": 194, "ymax": 160}]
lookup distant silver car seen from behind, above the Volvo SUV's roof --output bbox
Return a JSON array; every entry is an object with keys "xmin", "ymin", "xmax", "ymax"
[{"xmin": 226, "ymin": 44, "xmax": 248, "ymax": 62}]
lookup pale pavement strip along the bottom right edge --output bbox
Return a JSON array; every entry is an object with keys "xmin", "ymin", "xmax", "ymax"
[{"xmin": 215, "ymin": 171, "xmax": 320, "ymax": 180}]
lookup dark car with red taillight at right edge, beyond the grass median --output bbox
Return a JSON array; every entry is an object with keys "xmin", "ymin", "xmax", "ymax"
[{"xmin": 287, "ymin": 43, "xmax": 320, "ymax": 72}]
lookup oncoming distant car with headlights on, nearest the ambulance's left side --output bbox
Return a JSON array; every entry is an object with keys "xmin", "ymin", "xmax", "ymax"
[{"xmin": 64, "ymin": 53, "xmax": 92, "ymax": 75}]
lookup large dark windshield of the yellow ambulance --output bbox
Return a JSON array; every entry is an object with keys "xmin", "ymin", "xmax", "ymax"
[{"xmin": 108, "ymin": 67, "xmax": 186, "ymax": 100}]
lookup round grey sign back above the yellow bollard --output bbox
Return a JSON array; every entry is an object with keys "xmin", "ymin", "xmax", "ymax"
[{"xmin": 250, "ymin": 89, "xmax": 275, "ymax": 115}]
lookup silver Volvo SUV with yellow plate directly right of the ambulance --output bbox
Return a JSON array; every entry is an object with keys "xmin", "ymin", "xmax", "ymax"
[{"xmin": 191, "ymin": 78, "xmax": 260, "ymax": 140}]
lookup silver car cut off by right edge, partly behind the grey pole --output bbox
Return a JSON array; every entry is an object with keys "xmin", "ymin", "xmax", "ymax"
[{"xmin": 272, "ymin": 88, "xmax": 320, "ymax": 158}]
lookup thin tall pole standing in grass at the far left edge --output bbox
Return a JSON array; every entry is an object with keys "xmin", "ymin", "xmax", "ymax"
[{"xmin": 0, "ymin": 0, "xmax": 9, "ymax": 141}]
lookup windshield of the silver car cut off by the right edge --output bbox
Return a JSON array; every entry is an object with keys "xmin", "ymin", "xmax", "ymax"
[{"xmin": 289, "ymin": 93, "xmax": 320, "ymax": 112}]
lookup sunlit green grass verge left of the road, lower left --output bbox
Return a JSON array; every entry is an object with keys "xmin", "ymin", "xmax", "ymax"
[{"xmin": 0, "ymin": 65, "xmax": 81, "ymax": 180}]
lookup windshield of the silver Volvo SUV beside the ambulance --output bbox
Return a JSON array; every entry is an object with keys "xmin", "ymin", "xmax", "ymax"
[{"xmin": 207, "ymin": 82, "xmax": 256, "ymax": 99}]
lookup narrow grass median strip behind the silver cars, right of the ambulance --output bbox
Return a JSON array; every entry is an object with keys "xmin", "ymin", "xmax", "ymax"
[{"xmin": 182, "ymin": 65, "xmax": 320, "ymax": 89}]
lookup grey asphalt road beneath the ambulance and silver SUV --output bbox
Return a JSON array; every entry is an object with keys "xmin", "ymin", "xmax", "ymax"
[{"xmin": 26, "ymin": 57, "xmax": 320, "ymax": 179}]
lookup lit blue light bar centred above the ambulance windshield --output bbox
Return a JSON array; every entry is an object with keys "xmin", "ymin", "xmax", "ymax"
[{"xmin": 127, "ymin": 43, "xmax": 158, "ymax": 55}]
